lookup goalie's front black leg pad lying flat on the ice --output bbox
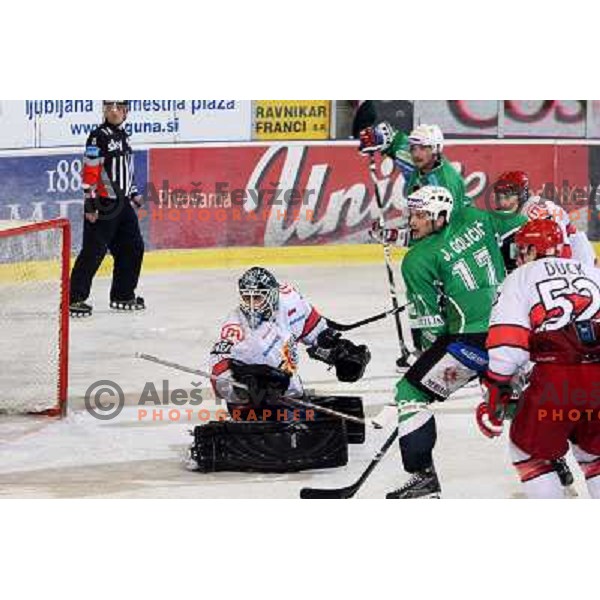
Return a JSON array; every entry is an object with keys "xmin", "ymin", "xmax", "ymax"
[{"xmin": 191, "ymin": 418, "xmax": 348, "ymax": 473}]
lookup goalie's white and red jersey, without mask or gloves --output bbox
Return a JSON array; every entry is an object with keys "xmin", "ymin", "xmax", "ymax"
[{"xmin": 210, "ymin": 283, "xmax": 327, "ymax": 399}]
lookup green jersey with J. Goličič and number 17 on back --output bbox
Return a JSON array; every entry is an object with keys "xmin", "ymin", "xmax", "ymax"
[{"xmin": 402, "ymin": 207, "xmax": 527, "ymax": 349}]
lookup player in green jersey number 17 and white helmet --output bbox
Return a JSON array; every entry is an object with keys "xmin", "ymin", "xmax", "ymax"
[{"xmin": 387, "ymin": 186, "xmax": 527, "ymax": 498}]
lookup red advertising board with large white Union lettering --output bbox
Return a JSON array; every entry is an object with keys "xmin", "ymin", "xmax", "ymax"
[{"xmin": 148, "ymin": 143, "xmax": 588, "ymax": 249}]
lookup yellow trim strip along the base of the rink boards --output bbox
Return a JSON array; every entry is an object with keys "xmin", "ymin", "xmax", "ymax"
[{"xmin": 0, "ymin": 242, "xmax": 600, "ymax": 282}]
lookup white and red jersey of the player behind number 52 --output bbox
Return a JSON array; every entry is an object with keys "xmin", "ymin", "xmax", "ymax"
[{"xmin": 520, "ymin": 196, "xmax": 596, "ymax": 266}]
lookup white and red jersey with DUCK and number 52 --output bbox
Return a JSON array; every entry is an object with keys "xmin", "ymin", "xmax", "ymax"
[{"xmin": 487, "ymin": 257, "xmax": 600, "ymax": 379}]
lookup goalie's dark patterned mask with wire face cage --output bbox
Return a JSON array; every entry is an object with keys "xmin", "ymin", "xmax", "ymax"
[{"xmin": 238, "ymin": 267, "xmax": 279, "ymax": 329}]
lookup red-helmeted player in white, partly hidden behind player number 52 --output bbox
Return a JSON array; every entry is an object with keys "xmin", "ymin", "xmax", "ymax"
[{"xmin": 494, "ymin": 171, "xmax": 596, "ymax": 270}]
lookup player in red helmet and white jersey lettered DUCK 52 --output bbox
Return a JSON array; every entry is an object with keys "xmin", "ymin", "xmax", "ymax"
[{"xmin": 477, "ymin": 220, "xmax": 600, "ymax": 498}]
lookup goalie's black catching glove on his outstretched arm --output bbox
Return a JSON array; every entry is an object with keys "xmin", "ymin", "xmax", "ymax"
[{"xmin": 307, "ymin": 329, "xmax": 371, "ymax": 383}]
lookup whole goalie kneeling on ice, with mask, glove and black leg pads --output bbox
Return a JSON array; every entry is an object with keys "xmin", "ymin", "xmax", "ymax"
[{"xmin": 186, "ymin": 267, "xmax": 371, "ymax": 472}]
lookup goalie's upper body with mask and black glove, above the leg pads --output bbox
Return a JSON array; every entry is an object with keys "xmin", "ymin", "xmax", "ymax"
[{"xmin": 210, "ymin": 267, "xmax": 371, "ymax": 419}]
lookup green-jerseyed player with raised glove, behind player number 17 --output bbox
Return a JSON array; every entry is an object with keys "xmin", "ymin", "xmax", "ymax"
[{"xmin": 360, "ymin": 121, "xmax": 471, "ymax": 211}]
